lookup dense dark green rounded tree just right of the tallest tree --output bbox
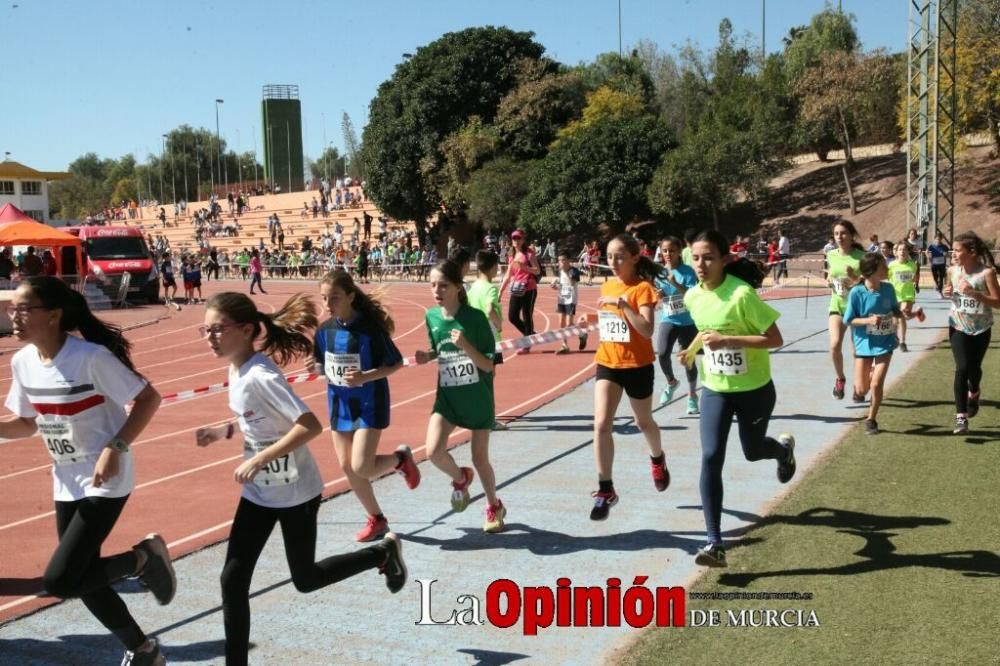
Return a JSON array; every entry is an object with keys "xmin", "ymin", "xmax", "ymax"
[{"xmin": 521, "ymin": 114, "xmax": 674, "ymax": 236}]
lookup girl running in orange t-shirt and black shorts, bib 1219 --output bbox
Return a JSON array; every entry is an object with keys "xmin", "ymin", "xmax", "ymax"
[{"xmin": 581, "ymin": 234, "xmax": 670, "ymax": 520}]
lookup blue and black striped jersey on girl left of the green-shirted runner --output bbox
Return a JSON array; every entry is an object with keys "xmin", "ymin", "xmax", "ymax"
[{"xmin": 314, "ymin": 313, "xmax": 403, "ymax": 432}]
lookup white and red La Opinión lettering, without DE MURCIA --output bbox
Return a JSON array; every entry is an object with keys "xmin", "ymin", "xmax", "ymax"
[{"xmin": 415, "ymin": 576, "xmax": 687, "ymax": 636}]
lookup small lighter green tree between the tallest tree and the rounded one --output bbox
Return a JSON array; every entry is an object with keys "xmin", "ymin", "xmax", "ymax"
[{"xmin": 465, "ymin": 157, "xmax": 539, "ymax": 231}]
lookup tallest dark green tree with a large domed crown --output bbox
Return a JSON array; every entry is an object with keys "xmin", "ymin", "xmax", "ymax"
[{"xmin": 361, "ymin": 27, "xmax": 544, "ymax": 242}]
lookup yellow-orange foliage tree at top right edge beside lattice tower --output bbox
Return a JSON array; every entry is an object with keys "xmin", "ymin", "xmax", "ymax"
[{"xmin": 955, "ymin": 0, "xmax": 1000, "ymax": 155}]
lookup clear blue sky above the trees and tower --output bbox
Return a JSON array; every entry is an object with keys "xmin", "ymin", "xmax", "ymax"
[{"xmin": 0, "ymin": 0, "xmax": 909, "ymax": 171}]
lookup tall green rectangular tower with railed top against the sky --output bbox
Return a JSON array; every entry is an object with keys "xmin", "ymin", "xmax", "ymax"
[{"xmin": 260, "ymin": 85, "xmax": 305, "ymax": 192}]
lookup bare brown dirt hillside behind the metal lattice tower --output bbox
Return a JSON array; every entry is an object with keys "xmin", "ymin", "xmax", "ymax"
[{"xmin": 756, "ymin": 146, "xmax": 1000, "ymax": 253}]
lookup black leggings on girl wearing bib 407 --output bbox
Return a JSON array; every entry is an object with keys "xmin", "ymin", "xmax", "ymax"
[{"xmin": 221, "ymin": 495, "xmax": 386, "ymax": 666}]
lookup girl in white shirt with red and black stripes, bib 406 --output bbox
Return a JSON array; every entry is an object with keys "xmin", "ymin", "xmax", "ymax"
[{"xmin": 0, "ymin": 277, "xmax": 177, "ymax": 665}]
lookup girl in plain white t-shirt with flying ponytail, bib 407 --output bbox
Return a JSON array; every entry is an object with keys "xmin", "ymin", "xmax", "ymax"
[{"xmin": 195, "ymin": 292, "xmax": 406, "ymax": 666}]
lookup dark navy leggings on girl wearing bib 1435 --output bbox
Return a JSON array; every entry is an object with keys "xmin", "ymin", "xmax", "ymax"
[{"xmin": 700, "ymin": 382, "xmax": 786, "ymax": 543}]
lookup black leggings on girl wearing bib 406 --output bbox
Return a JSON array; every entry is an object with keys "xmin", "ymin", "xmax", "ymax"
[{"xmin": 43, "ymin": 496, "xmax": 146, "ymax": 652}]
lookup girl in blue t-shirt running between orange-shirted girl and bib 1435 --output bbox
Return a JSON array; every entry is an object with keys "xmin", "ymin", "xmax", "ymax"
[{"xmin": 654, "ymin": 236, "xmax": 698, "ymax": 414}]
